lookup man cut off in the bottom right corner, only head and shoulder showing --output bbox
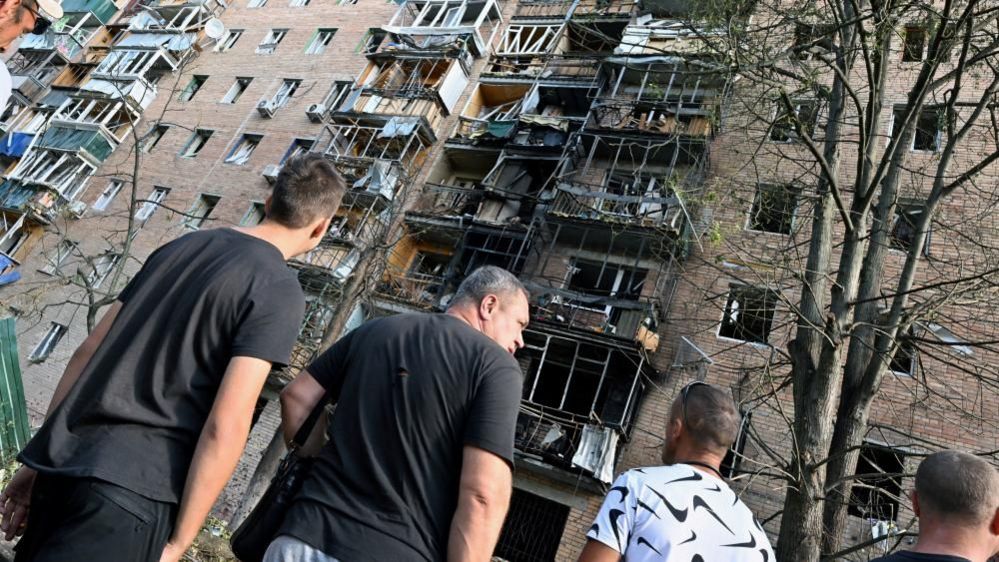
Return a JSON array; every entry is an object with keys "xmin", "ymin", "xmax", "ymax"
[{"xmin": 872, "ymin": 451, "xmax": 999, "ymax": 562}]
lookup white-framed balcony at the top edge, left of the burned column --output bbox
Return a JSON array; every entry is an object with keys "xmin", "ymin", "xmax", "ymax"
[{"xmin": 383, "ymin": 0, "xmax": 502, "ymax": 56}]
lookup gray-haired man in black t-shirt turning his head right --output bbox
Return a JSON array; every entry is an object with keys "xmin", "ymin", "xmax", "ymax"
[{"xmin": 264, "ymin": 266, "xmax": 529, "ymax": 562}]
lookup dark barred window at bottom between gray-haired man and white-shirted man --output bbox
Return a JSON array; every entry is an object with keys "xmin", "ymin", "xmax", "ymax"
[{"xmin": 493, "ymin": 488, "xmax": 569, "ymax": 562}]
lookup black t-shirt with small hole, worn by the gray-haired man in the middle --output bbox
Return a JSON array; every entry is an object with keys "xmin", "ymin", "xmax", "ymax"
[{"xmin": 281, "ymin": 314, "xmax": 523, "ymax": 562}]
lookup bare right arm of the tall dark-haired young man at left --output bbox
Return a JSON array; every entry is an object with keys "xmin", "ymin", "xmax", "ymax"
[{"xmin": 167, "ymin": 357, "xmax": 271, "ymax": 551}]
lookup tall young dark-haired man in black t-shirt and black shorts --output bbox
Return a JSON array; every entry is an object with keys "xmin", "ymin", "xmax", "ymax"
[{"xmin": 0, "ymin": 154, "xmax": 345, "ymax": 562}]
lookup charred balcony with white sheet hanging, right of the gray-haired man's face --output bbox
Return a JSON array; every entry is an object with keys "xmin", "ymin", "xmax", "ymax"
[{"xmin": 515, "ymin": 325, "xmax": 651, "ymax": 483}]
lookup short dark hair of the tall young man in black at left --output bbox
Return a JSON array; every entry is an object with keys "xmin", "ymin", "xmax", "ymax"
[{"xmin": 267, "ymin": 153, "xmax": 347, "ymax": 228}]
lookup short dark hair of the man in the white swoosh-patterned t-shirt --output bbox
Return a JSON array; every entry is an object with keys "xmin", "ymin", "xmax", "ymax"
[{"xmin": 670, "ymin": 384, "xmax": 741, "ymax": 454}]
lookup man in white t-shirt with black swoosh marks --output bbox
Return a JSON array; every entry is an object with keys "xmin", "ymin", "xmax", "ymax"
[{"xmin": 579, "ymin": 381, "xmax": 774, "ymax": 562}]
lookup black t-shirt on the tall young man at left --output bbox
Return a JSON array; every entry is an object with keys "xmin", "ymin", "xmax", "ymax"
[{"xmin": 20, "ymin": 229, "xmax": 305, "ymax": 502}]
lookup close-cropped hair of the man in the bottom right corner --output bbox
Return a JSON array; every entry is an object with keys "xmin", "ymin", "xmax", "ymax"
[{"xmin": 916, "ymin": 451, "xmax": 999, "ymax": 526}]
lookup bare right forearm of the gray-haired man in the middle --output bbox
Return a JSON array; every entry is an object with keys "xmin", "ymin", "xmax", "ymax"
[{"xmin": 447, "ymin": 446, "xmax": 513, "ymax": 562}]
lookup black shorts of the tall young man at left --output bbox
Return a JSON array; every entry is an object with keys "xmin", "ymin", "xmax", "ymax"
[{"xmin": 14, "ymin": 473, "xmax": 177, "ymax": 562}]
